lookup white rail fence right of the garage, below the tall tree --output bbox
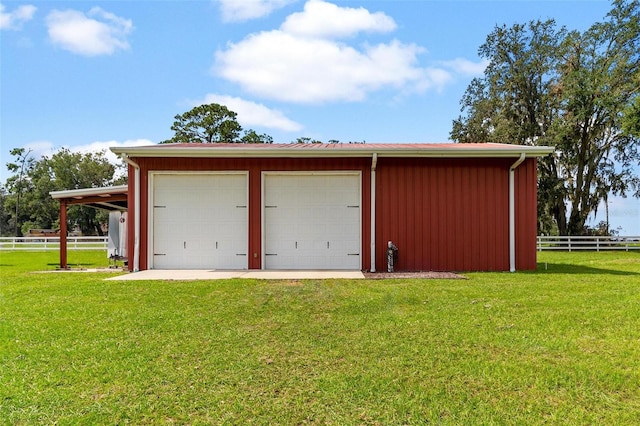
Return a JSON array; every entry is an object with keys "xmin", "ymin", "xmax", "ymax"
[{"xmin": 537, "ymin": 235, "xmax": 640, "ymax": 251}]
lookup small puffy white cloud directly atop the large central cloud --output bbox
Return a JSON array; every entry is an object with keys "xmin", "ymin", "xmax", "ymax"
[{"xmin": 280, "ymin": 0, "xmax": 396, "ymax": 38}]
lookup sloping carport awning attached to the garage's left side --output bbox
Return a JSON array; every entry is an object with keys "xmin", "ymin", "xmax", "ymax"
[{"xmin": 49, "ymin": 185, "xmax": 129, "ymax": 211}]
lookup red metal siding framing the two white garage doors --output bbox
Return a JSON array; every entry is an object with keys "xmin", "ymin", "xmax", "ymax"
[{"xmin": 129, "ymin": 158, "xmax": 371, "ymax": 270}]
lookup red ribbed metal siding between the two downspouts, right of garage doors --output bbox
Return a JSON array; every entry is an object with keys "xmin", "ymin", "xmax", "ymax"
[{"xmin": 376, "ymin": 158, "xmax": 512, "ymax": 271}]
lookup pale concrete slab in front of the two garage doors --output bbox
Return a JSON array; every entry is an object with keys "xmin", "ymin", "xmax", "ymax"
[{"xmin": 106, "ymin": 269, "xmax": 364, "ymax": 281}]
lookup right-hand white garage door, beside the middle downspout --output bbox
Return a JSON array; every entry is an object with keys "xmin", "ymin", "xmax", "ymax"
[{"xmin": 263, "ymin": 174, "xmax": 361, "ymax": 269}]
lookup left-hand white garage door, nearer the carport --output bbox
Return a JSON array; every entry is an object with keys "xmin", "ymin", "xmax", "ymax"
[{"xmin": 152, "ymin": 173, "xmax": 248, "ymax": 269}]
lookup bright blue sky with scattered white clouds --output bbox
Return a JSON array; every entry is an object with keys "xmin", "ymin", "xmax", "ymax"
[{"xmin": 0, "ymin": 0, "xmax": 640, "ymax": 235}]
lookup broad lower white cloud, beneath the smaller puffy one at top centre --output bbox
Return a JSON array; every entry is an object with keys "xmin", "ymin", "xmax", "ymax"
[{"xmin": 214, "ymin": 30, "xmax": 446, "ymax": 103}]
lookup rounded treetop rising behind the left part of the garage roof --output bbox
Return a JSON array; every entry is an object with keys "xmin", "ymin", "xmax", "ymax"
[{"xmin": 162, "ymin": 104, "xmax": 242, "ymax": 143}]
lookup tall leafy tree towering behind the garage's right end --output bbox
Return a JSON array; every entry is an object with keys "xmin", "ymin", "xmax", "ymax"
[{"xmin": 451, "ymin": 0, "xmax": 640, "ymax": 235}]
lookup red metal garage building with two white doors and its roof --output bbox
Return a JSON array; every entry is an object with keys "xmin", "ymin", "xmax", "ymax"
[{"xmin": 112, "ymin": 144, "xmax": 552, "ymax": 271}]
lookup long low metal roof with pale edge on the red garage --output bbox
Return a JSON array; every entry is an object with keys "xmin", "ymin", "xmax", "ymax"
[{"xmin": 111, "ymin": 143, "xmax": 554, "ymax": 158}]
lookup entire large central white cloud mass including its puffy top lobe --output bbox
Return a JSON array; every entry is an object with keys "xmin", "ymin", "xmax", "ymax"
[{"xmin": 212, "ymin": 0, "xmax": 455, "ymax": 103}]
